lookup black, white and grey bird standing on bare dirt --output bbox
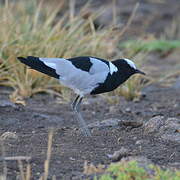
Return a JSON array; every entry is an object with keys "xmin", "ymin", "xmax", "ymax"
[{"xmin": 17, "ymin": 56, "xmax": 145, "ymax": 136}]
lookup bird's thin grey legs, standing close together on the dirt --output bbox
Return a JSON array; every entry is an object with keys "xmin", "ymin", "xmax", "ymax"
[{"xmin": 72, "ymin": 95, "xmax": 91, "ymax": 136}]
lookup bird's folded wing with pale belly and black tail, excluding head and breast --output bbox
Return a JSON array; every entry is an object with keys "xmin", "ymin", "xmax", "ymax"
[{"xmin": 18, "ymin": 56, "xmax": 110, "ymax": 95}]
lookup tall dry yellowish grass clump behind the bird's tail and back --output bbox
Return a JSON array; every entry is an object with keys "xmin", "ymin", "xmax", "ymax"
[{"xmin": 0, "ymin": 1, "xmax": 148, "ymax": 105}]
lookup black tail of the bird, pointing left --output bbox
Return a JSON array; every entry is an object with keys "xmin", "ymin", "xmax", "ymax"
[{"xmin": 17, "ymin": 56, "xmax": 59, "ymax": 79}]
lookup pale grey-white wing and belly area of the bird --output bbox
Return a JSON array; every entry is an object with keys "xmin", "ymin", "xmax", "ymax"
[{"xmin": 39, "ymin": 58, "xmax": 109, "ymax": 96}]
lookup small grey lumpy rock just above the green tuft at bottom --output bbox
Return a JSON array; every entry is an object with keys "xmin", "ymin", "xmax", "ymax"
[{"xmin": 107, "ymin": 147, "xmax": 132, "ymax": 162}]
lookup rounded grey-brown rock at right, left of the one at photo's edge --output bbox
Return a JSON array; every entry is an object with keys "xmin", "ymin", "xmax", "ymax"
[{"xmin": 144, "ymin": 116, "xmax": 164, "ymax": 133}]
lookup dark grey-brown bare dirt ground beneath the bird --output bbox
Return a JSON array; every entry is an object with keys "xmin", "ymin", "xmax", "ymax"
[{"xmin": 0, "ymin": 1, "xmax": 180, "ymax": 179}]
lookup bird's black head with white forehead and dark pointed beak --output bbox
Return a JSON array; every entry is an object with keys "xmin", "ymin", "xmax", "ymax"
[{"xmin": 114, "ymin": 59, "xmax": 145, "ymax": 76}]
